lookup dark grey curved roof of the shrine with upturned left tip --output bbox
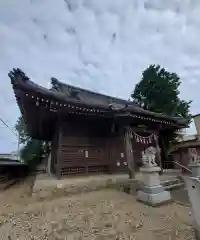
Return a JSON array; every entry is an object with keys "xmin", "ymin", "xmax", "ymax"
[{"xmin": 8, "ymin": 69, "xmax": 189, "ymax": 127}]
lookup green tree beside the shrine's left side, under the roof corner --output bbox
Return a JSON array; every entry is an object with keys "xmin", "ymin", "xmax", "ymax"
[{"xmin": 15, "ymin": 116, "xmax": 50, "ymax": 166}]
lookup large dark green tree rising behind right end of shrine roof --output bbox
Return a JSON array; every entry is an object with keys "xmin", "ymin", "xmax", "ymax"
[{"xmin": 131, "ymin": 65, "xmax": 192, "ymax": 163}]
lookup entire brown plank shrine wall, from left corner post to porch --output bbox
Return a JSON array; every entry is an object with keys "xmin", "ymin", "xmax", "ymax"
[{"xmin": 55, "ymin": 122, "xmax": 127, "ymax": 176}]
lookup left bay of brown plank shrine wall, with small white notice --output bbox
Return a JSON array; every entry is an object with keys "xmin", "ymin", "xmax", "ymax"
[{"xmin": 59, "ymin": 122, "xmax": 109, "ymax": 175}]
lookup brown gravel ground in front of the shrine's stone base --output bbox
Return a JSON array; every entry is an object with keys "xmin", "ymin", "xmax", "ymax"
[{"xmin": 0, "ymin": 181, "xmax": 194, "ymax": 240}]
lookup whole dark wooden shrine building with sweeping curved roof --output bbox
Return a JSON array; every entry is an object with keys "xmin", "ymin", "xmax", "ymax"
[{"xmin": 9, "ymin": 69, "xmax": 188, "ymax": 178}]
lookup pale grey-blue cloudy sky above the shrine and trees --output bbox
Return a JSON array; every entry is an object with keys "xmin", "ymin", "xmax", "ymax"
[{"xmin": 0, "ymin": 0, "xmax": 200, "ymax": 152}]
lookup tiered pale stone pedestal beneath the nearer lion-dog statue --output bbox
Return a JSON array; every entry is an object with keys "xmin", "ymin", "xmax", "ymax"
[{"xmin": 137, "ymin": 166, "xmax": 171, "ymax": 206}]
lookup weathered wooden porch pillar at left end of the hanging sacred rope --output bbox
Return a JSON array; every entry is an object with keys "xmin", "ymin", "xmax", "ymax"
[{"xmin": 124, "ymin": 127, "xmax": 135, "ymax": 178}]
